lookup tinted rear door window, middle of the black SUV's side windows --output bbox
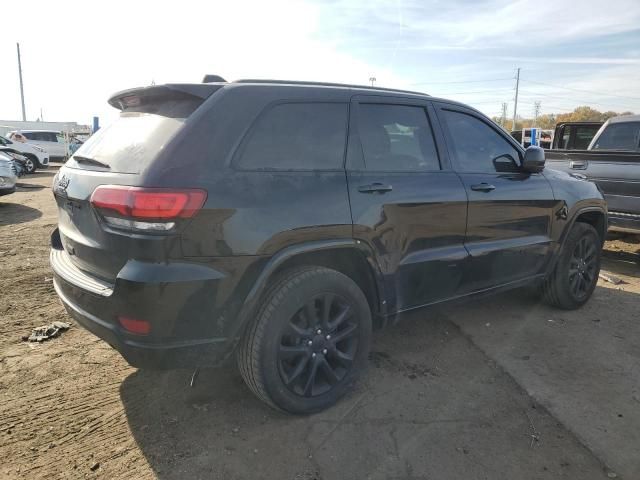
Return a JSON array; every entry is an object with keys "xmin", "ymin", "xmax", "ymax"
[{"xmin": 358, "ymin": 104, "xmax": 440, "ymax": 171}]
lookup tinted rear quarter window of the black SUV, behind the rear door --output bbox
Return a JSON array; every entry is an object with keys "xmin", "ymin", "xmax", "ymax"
[{"xmin": 234, "ymin": 103, "xmax": 348, "ymax": 170}]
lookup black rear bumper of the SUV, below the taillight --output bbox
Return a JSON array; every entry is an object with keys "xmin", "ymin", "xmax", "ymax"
[{"xmin": 50, "ymin": 231, "xmax": 252, "ymax": 369}]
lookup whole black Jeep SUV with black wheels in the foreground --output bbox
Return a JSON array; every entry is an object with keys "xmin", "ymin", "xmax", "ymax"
[{"xmin": 51, "ymin": 80, "xmax": 607, "ymax": 413}]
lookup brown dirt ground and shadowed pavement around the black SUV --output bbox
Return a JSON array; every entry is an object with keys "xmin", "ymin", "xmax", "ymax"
[{"xmin": 0, "ymin": 166, "xmax": 640, "ymax": 480}]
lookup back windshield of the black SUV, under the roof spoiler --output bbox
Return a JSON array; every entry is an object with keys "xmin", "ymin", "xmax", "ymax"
[{"xmin": 67, "ymin": 99, "xmax": 202, "ymax": 173}]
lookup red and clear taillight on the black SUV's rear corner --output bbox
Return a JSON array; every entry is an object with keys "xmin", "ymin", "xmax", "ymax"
[{"xmin": 91, "ymin": 185, "xmax": 207, "ymax": 231}]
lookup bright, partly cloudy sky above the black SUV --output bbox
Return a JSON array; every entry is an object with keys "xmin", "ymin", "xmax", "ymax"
[{"xmin": 0, "ymin": 0, "xmax": 640, "ymax": 125}]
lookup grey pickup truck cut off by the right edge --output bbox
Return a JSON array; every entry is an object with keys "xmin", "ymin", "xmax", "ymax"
[{"xmin": 547, "ymin": 115, "xmax": 640, "ymax": 233}]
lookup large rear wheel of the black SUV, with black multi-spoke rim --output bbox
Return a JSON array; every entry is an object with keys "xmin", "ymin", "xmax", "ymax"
[{"xmin": 237, "ymin": 267, "xmax": 372, "ymax": 414}]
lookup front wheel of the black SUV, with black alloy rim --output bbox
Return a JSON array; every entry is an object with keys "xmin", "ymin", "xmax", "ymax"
[{"xmin": 543, "ymin": 222, "xmax": 602, "ymax": 310}]
